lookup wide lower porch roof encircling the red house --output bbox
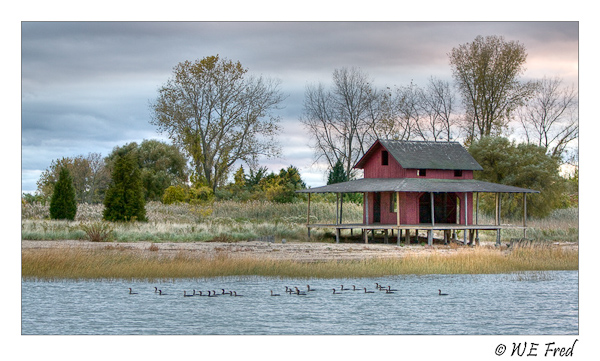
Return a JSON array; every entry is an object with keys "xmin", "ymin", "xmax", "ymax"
[{"xmin": 296, "ymin": 178, "xmax": 539, "ymax": 193}]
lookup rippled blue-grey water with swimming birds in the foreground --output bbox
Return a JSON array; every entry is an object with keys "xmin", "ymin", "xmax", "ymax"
[{"xmin": 21, "ymin": 271, "xmax": 579, "ymax": 335}]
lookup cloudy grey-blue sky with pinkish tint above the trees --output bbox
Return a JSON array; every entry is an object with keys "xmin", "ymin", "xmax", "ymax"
[{"xmin": 21, "ymin": 21, "xmax": 579, "ymax": 192}]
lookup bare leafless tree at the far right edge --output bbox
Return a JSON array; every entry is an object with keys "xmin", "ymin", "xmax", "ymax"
[{"xmin": 517, "ymin": 77, "xmax": 579, "ymax": 157}]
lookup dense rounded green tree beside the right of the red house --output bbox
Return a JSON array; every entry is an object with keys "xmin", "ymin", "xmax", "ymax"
[{"xmin": 469, "ymin": 137, "xmax": 566, "ymax": 217}]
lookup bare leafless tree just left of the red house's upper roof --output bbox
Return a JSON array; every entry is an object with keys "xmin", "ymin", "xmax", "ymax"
[{"xmin": 300, "ymin": 68, "xmax": 377, "ymax": 179}]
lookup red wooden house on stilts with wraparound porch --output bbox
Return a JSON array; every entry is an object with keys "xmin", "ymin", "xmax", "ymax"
[{"xmin": 299, "ymin": 140, "xmax": 539, "ymax": 244}]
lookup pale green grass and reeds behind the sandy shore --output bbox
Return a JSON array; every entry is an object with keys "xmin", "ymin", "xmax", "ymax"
[{"xmin": 21, "ymin": 201, "xmax": 579, "ymax": 242}]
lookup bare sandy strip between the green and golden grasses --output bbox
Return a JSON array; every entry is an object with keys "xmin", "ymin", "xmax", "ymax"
[{"xmin": 21, "ymin": 240, "xmax": 578, "ymax": 262}]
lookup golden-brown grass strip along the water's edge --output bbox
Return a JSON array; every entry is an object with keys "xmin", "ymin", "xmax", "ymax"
[{"xmin": 21, "ymin": 247, "xmax": 579, "ymax": 280}]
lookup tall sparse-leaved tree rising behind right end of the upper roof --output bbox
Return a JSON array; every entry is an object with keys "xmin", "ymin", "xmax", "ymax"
[{"xmin": 448, "ymin": 36, "xmax": 535, "ymax": 143}]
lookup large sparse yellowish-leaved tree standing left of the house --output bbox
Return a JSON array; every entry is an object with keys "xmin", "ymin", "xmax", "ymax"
[{"xmin": 151, "ymin": 55, "xmax": 284, "ymax": 191}]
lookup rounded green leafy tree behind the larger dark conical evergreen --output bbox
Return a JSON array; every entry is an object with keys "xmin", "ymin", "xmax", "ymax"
[{"xmin": 106, "ymin": 139, "xmax": 188, "ymax": 201}]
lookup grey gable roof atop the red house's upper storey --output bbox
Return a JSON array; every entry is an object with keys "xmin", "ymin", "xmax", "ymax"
[{"xmin": 355, "ymin": 139, "xmax": 483, "ymax": 170}]
